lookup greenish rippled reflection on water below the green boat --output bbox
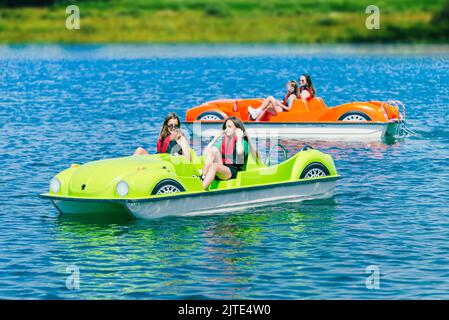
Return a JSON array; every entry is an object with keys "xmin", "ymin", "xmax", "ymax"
[{"xmin": 51, "ymin": 199, "xmax": 338, "ymax": 299}]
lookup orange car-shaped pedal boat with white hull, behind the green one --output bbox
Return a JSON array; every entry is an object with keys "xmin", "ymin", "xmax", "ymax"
[{"xmin": 185, "ymin": 97, "xmax": 405, "ymax": 141}]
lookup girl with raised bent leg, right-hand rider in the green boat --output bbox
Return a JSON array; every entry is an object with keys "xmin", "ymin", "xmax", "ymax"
[{"xmin": 202, "ymin": 117, "xmax": 257, "ymax": 189}]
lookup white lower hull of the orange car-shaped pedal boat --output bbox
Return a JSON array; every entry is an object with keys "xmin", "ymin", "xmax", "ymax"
[{"xmin": 185, "ymin": 122, "xmax": 398, "ymax": 141}]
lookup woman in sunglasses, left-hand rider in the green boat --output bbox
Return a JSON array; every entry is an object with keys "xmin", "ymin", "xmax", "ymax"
[{"xmin": 134, "ymin": 113, "xmax": 190, "ymax": 161}]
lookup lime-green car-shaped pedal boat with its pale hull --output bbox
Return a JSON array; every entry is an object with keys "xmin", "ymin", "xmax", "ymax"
[{"xmin": 40, "ymin": 148, "xmax": 340, "ymax": 219}]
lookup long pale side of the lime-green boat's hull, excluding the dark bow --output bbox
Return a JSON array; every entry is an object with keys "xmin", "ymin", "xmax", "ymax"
[{"xmin": 124, "ymin": 178, "xmax": 338, "ymax": 219}]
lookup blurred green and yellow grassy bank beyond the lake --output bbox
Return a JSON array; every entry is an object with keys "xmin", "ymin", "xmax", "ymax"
[{"xmin": 0, "ymin": 0, "xmax": 449, "ymax": 43}]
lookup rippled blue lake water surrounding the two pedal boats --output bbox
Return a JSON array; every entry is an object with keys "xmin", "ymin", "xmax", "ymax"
[{"xmin": 0, "ymin": 46, "xmax": 449, "ymax": 299}]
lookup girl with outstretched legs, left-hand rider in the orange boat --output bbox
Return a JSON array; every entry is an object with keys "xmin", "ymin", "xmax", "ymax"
[{"xmin": 248, "ymin": 80, "xmax": 298, "ymax": 121}]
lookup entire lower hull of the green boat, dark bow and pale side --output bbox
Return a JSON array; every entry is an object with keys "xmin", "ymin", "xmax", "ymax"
[{"xmin": 41, "ymin": 177, "xmax": 339, "ymax": 219}]
